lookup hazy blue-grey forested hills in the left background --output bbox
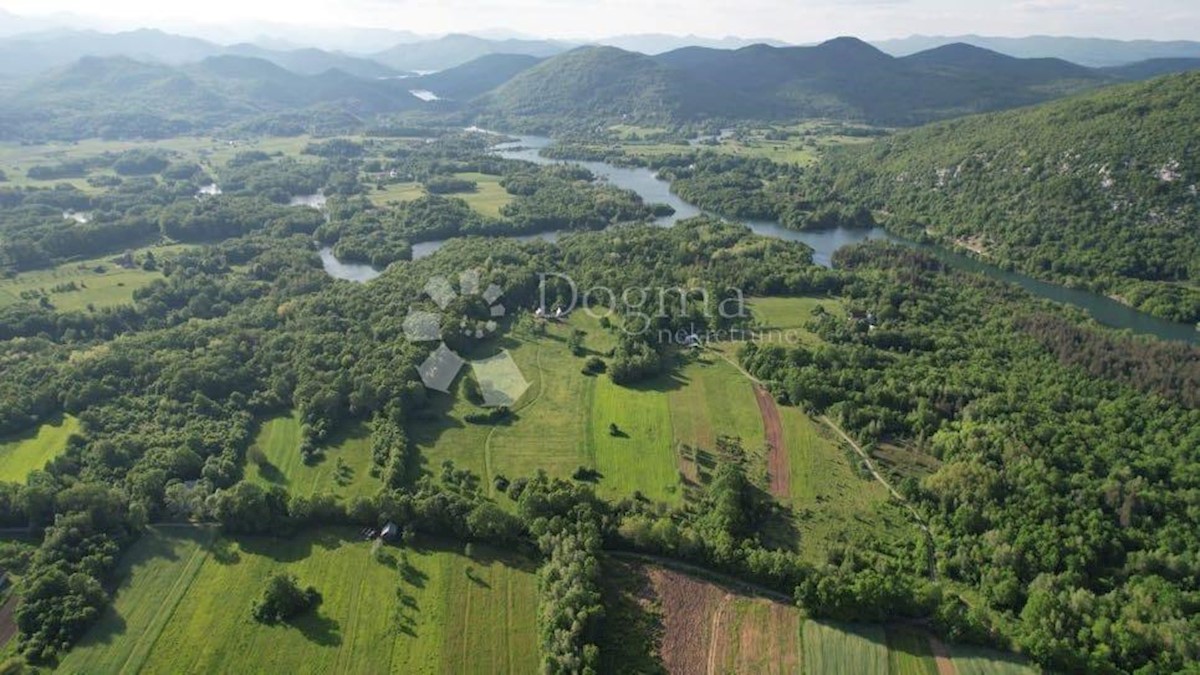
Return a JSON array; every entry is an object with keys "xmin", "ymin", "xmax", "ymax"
[{"xmin": 0, "ymin": 55, "xmax": 421, "ymax": 139}]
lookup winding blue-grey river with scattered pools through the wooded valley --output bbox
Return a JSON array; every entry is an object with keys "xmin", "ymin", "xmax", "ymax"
[{"xmin": 322, "ymin": 130, "xmax": 1200, "ymax": 344}]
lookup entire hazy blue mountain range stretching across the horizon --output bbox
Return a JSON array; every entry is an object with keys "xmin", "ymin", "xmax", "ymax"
[{"xmin": 7, "ymin": 31, "xmax": 1200, "ymax": 138}]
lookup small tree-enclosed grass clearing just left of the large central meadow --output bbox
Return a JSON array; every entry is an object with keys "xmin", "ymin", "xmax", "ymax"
[{"xmin": 246, "ymin": 414, "xmax": 379, "ymax": 497}]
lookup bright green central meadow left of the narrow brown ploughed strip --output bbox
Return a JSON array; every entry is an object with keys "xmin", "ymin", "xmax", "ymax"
[{"xmin": 413, "ymin": 312, "xmax": 762, "ymax": 502}]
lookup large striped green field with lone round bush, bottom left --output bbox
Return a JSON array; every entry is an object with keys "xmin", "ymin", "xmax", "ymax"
[{"xmin": 60, "ymin": 528, "xmax": 538, "ymax": 673}]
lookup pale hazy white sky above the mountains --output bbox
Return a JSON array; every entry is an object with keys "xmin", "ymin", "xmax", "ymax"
[{"xmin": 0, "ymin": 0, "xmax": 1200, "ymax": 42}]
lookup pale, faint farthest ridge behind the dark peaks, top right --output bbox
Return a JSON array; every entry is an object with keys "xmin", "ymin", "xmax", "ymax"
[{"xmin": 872, "ymin": 35, "xmax": 1200, "ymax": 67}]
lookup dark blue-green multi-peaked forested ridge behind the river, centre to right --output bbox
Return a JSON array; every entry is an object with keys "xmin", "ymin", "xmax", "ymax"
[{"xmin": 480, "ymin": 37, "xmax": 1188, "ymax": 126}]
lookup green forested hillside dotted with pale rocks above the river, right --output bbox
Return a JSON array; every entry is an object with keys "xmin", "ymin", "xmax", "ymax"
[{"xmin": 822, "ymin": 73, "xmax": 1200, "ymax": 322}]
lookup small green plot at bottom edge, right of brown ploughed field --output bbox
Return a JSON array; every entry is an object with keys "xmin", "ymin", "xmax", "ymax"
[{"xmin": 802, "ymin": 620, "xmax": 888, "ymax": 675}]
